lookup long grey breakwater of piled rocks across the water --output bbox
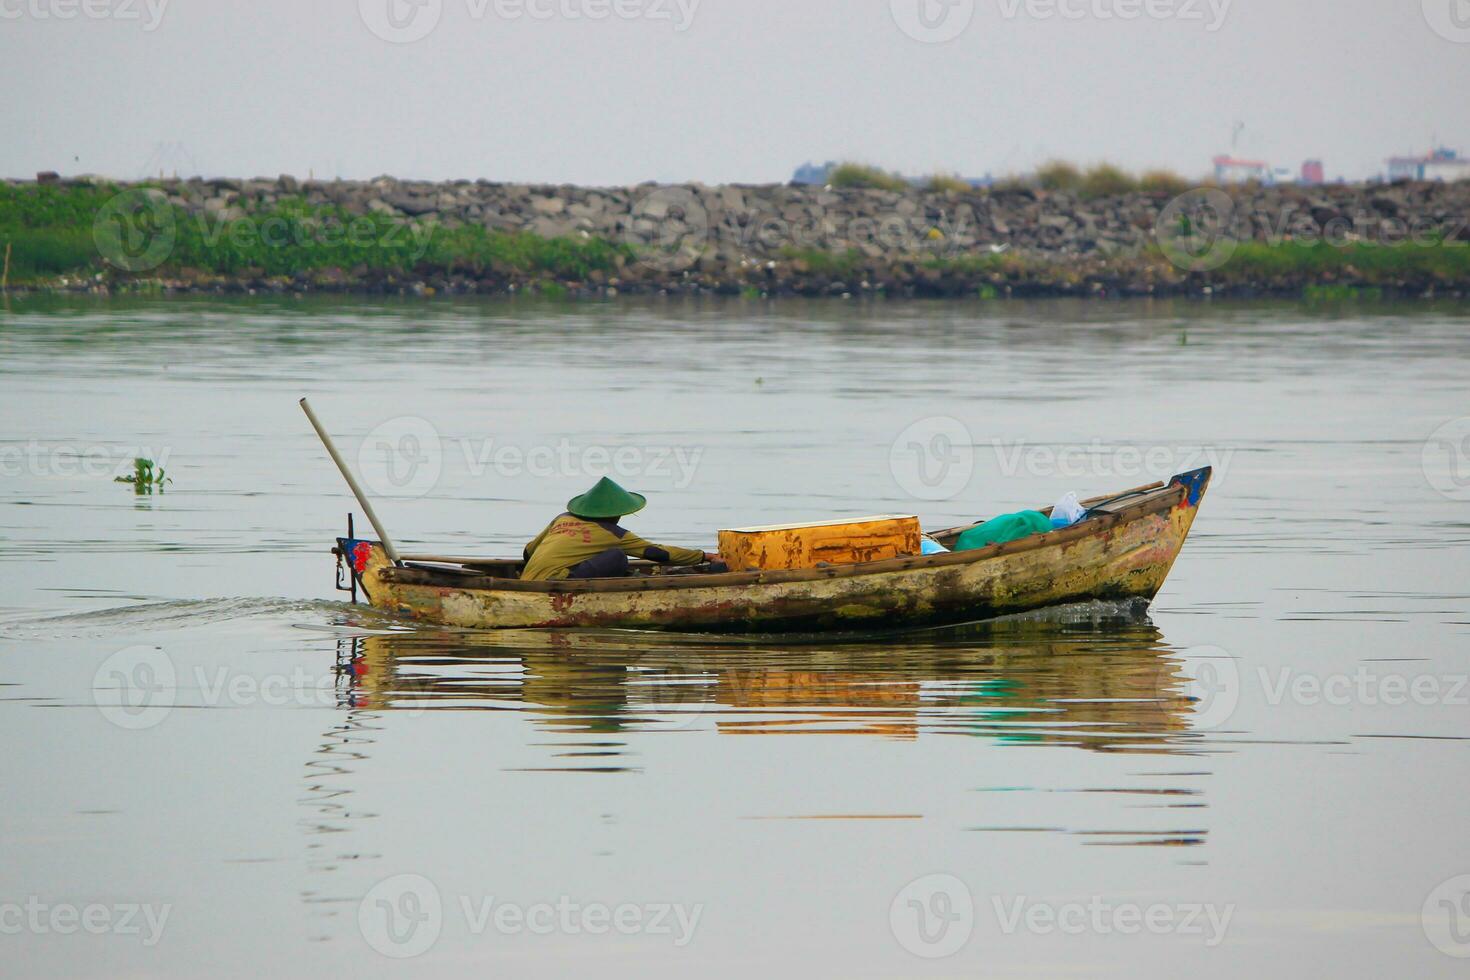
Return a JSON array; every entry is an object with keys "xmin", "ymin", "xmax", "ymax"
[{"xmin": 14, "ymin": 176, "xmax": 1470, "ymax": 297}]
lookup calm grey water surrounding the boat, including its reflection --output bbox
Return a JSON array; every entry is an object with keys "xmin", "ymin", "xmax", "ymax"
[{"xmin": 0, "ymin": 301, "xmax": 1470, "ymax": 977}]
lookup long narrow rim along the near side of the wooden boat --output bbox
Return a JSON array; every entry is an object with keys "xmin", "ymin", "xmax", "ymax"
[{"xmin": 378, "ymin": 483, "xmax": 1189, "ymax": 595}]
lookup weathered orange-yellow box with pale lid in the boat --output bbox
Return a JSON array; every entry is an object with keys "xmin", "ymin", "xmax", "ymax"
[{"xmin": 720, "ymin": 514, "xmax": 920, "ymax": 572}]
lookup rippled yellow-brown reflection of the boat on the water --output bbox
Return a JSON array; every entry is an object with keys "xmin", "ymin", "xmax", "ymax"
[{"xmin": 343, "ymin": 605, "xmax": 1198, "ymax": 752}]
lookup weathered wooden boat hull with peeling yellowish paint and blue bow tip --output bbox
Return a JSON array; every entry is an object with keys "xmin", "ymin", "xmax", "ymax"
[{"xmin": 335, "ymin": 467, "xmax": 1211, "ymax": 633}]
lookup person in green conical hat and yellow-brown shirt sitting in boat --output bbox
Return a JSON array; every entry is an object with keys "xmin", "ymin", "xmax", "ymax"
[{"xmin": 520, "ymin": 476, "xmax": 720, "ymax": 582}]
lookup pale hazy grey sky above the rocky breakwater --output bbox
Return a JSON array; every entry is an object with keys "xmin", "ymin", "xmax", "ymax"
[{"xmin": 0, "ymin": 0, "xmax": 1470, "ymax": 184}]
